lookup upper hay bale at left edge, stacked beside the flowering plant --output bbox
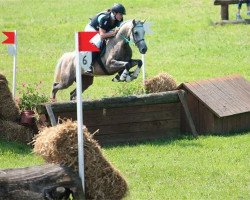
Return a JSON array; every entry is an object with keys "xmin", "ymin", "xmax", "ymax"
[{"xmin": 0, "ymin": 73, "xmax": 20, "ymax": 121}]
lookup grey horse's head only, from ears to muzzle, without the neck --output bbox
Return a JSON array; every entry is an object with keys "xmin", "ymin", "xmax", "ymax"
[{"xmin": 130, "ymin": 20, "xmax": 148, "ymax": 54}]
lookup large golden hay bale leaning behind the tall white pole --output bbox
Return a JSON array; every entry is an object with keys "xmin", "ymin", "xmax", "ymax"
[{"xmin": 34, "ymin": 120, "xmax": 128, "ymax": 200}]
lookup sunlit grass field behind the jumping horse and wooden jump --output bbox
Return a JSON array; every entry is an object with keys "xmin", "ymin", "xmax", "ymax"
[{"xmin": 0, "ymin": 0, "xmax": 250, "ymax": 100}]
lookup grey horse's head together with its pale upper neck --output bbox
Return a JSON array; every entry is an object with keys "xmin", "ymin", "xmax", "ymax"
[{"xmin": 118, "ymin": 20, "xmax": 148, "ymax": 54}]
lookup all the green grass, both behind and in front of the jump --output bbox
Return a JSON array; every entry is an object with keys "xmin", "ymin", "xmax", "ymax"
[{"xmin": 0, "ymin": 0, "xmax": 250, "ymax": 200}]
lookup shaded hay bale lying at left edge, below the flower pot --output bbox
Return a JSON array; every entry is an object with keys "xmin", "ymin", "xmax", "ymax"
[{"xmin": 0, "ymin": 119, "xmax": 34, "ymax": 144}]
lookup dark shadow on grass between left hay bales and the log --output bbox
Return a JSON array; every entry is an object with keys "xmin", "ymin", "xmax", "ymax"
[{"xmin": 0, "ymin": 139, "xmax": 32, "ymax": 155}]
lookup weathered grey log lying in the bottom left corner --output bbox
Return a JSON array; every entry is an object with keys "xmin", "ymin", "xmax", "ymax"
[{"xmin": 0, "ymin": 164, "xmax": 84, "ymax": 200}]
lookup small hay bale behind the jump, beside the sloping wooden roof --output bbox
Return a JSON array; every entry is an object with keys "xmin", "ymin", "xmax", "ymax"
[{"xmin": 144, "ymin": 73, "xmax": 177, "ymax": 93}]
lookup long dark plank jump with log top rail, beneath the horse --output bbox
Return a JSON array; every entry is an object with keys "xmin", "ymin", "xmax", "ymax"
[{"xmin": 38, "ymin": 90, "xmax": 196, "ymax": 145}]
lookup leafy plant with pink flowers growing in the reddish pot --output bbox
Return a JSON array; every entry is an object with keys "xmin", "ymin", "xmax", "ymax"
[{"xmin": 17, "ymin": 81, "xmax": 49, "ymax": 111}]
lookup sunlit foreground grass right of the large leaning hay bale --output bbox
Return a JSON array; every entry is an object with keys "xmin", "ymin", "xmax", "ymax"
[{"xmin": 102, "ymin": 134, "xmax": 250, "ymax": 200}]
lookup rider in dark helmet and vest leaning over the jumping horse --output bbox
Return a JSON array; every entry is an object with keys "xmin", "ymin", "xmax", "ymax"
[{"xmin": 84, "ymin": 3, "xmax": 126, "ymax": 72}]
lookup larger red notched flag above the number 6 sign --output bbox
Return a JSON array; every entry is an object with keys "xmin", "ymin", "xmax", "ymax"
[{"xmin": 78, "ymin": 31, "xmax": 100, "ymax": 52}]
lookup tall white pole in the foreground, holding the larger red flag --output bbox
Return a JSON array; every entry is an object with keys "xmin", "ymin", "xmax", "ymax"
[{"xmin": 75, "ymin": 32, "xmax": 85, "ymax": 194}]
